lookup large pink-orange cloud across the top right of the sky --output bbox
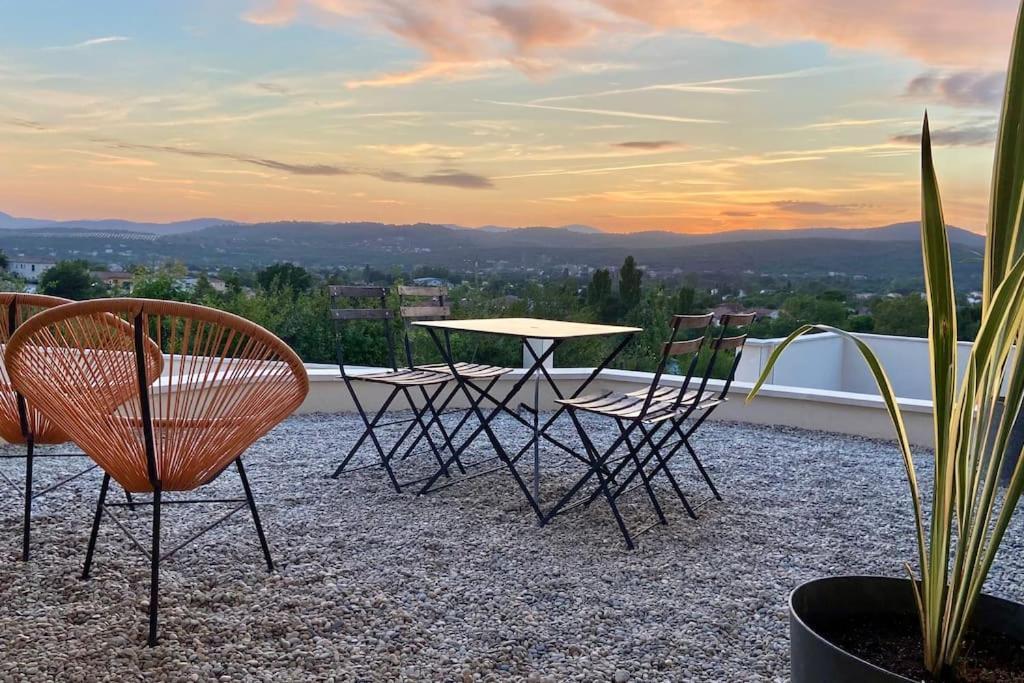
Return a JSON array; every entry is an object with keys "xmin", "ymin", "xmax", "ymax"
[{"xmin": 245, "ymin": 0, "xmax": 1015, "ymax": 87}]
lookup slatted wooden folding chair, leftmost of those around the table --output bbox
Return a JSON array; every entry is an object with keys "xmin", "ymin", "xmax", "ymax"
[{"xmin": 328, "ymin": 285, "xmax": 461, "ymax": 493}]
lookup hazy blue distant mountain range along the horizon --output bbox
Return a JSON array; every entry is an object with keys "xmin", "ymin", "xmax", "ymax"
[{"xmin": 0, "ymin": 214, "xmax": 984, "ymax": 289}]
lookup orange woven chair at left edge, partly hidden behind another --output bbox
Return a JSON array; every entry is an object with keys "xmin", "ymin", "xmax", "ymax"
[{"xmin": 0, "ymin": 292, "xmax": 154, "ymax": 560}]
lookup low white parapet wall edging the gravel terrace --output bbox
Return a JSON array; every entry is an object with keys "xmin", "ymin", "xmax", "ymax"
[{"xmin": 140, "ymin": 334, "xmax": 937, "ymax": 445}]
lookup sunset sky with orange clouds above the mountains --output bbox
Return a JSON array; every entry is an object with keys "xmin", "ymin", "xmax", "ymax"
[{"xmin": 0, "ymin": 0, "xmax": 1017, "ymax": 231}]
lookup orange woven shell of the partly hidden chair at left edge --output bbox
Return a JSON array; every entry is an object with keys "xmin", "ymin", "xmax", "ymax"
[{"xmin": 0, "ymin": 292, "xmax": 71, "ymax": 443}]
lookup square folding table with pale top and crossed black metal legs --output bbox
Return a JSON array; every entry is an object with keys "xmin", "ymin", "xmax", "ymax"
[{"xmin": 413, "ymin": 317, "xmax": 642, "ymax": 522}]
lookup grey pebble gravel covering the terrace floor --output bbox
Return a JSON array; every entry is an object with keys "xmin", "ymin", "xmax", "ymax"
[{"xmin": 0, "ymin": 415, "xmax": 1024, "ymax": 682}]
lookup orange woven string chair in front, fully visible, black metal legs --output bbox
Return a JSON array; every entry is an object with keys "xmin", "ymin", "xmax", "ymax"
[{"xmin": 5, "ymin": 299, "xmax": 309, "ymax": 645}]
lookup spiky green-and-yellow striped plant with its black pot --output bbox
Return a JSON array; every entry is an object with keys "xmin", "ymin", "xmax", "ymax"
[{"xmin": 748, "ymin": 4, "xmax": 1024, "ymax": 683}]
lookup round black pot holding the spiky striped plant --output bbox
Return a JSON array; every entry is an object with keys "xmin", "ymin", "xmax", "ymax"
[{"xmin": 790, "ymin": 577, "xmax": 1024, "ymax": 683}]
